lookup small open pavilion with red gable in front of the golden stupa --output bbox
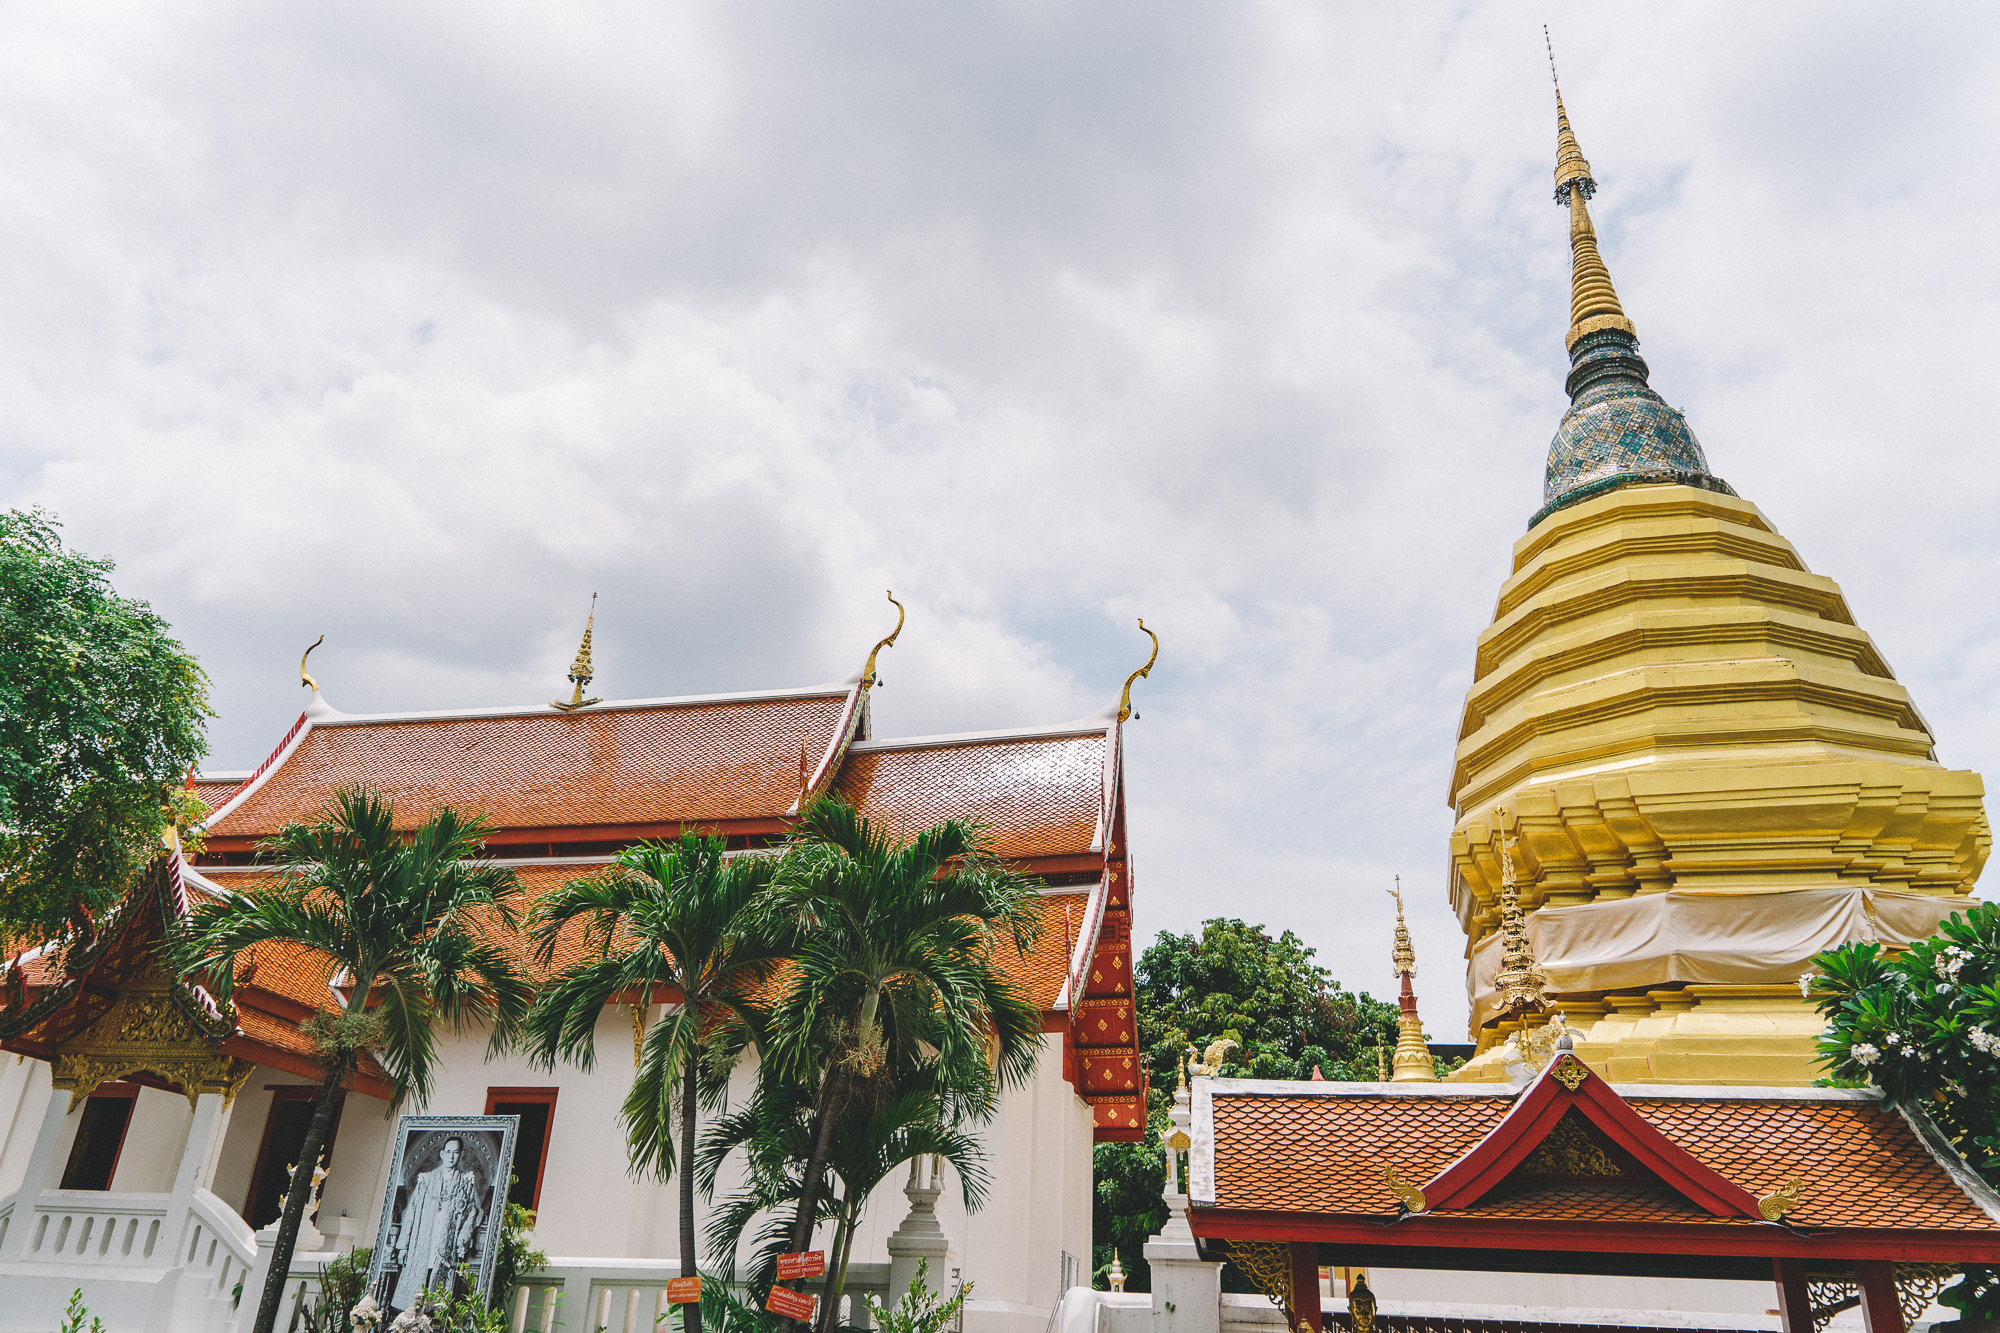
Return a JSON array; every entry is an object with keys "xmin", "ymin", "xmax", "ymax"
[{"xmin": 1186, "ymin": 1037, "xmax": 2000, "ymax": 1333}]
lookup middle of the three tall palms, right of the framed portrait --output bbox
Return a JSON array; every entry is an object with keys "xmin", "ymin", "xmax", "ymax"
[{"xmin": 526, "ymin": 833, "xmax": 786, "ymax": 1333}]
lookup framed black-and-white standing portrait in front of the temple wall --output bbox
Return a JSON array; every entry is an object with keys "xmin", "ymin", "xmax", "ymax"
[{"xmin": 368, "ymin": 1115, "xmax": 520, "ymax": 1317}]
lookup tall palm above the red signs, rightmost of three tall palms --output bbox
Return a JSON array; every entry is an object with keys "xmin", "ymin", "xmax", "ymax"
[{"xmin": 768, "ymin": 799, "xmax": 1042, "ymax": 1312}]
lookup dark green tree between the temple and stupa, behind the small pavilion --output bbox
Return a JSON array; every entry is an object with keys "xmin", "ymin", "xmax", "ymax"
[{"xmin": 1092, "ymin": 917, "xmax": 1396, "ymax": 1291}]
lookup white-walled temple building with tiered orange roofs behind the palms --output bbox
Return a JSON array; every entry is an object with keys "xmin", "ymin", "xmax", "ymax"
[{"xmin": 0, "ymin": 618, "xmax": 1150, "ymax": 1333}]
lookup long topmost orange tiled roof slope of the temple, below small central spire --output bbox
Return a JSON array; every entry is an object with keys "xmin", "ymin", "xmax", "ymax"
[{"xmin": 212, "ymin": 695, "xmax": 846, "ymax": 837}]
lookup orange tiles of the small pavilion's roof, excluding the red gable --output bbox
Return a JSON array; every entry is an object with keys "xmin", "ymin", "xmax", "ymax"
[{"xmin": 1212, "ymin": 1081, "xmax": 2000, "ymax": 1233}]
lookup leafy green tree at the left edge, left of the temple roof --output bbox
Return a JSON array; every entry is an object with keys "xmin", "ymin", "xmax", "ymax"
[{"xmin": 0, "ymin": 510, "xmax": 212, "ymax": 947}]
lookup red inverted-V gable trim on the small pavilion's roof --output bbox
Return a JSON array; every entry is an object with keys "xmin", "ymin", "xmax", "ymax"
[{"xmin": 1424, "ymin": 1053, "xmax": 1760, "ymax": 1217}]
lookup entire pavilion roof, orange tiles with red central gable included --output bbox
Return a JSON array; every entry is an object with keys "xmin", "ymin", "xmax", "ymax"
[{"xmin": 1192, "ymin": 1057, "xmax": 2000, "ymax": 1255}]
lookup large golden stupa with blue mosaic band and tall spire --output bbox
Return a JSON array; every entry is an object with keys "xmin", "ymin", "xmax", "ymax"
[{"xmin": 1450, "ymin": 90, "xmax": 1992, "ymax": 1085}]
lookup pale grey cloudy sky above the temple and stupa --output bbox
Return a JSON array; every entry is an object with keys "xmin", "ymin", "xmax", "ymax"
[{"xmin": 0, "ymin": 0, "xmax": 2000, "ymax": 1037}]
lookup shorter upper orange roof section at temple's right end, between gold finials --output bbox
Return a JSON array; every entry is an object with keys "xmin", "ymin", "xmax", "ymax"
[{"xmin": 834, "ymin": 731, "xmax": 1110, "ymax": 857}]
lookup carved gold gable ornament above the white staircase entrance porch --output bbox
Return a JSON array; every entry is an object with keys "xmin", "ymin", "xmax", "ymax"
[{"xmin": 50, "ymin": 967, "xmax": 256, "ymax": 1111}]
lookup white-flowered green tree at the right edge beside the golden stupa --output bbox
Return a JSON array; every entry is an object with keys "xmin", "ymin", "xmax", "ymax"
[{"xmin": 1800, "ymin": 903, "xmax": 2000, "ymax": 1319}]
